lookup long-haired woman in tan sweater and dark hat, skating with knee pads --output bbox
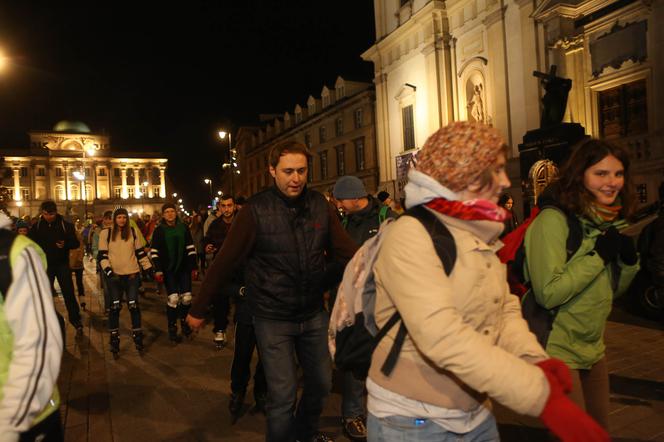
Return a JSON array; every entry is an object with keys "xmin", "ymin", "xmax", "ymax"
[{"xmin": 97, "ymin": 208, "xmax": 152, "ymax": 357}]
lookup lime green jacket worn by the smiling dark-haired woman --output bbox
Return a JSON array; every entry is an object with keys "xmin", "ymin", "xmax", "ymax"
[{"xmin": 524, "ymin": 208, "xmax": 639, "ymax": 369}]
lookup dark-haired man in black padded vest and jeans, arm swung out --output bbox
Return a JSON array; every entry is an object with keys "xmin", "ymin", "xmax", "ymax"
[{"xmin": 187, "ymin": 141, "xmax": 356, "ymax": 442}]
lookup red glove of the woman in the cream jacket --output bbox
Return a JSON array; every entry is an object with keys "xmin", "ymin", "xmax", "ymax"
[{"xmin": 537, "ymin": 359, "xmax": 611, "ymax": 442}]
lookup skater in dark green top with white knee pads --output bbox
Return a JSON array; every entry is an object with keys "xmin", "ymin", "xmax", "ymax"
[{"xmin": 150, "ymin": 203, "xmax": 198, "ymax": 343}]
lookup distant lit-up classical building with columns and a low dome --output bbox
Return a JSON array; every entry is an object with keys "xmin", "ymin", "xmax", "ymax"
[{"xmin": 0, "ymin": 121, "xmax": 168, "ymax": 217}]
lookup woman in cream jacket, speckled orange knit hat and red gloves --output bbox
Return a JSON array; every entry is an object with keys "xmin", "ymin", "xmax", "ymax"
[{"xmin": 367, "ymin": 122, "xmax": 608, "ymax": 441}]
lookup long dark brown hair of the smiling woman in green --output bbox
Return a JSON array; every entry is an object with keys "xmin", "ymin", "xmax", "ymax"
[{"xmin": 552, "ymin": 138, "xmax": 634, "ymax": 218}]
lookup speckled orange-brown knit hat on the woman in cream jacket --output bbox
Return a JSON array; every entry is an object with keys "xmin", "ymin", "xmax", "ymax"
[{"xmin": 416, "ymin": 121, "xmax": 506, "ymax": 192}]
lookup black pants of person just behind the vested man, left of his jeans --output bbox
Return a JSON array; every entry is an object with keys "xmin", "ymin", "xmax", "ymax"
[{"xmin": 231, "ymin": 322, "xmax": 267, "ymax": 399}]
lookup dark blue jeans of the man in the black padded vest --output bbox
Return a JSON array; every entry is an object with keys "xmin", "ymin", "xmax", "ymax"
[{"xmin": 254, "ymin": 311, "xmax": 332, "ymax": 442}]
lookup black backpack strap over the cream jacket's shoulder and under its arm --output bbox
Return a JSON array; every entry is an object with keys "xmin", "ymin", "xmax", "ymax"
[{"xmin": 374, "ymin": 206, "xmax": 457, "ymax": 376}]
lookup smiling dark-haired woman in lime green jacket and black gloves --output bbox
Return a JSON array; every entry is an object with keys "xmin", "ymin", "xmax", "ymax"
[{"xmin": 525, "ymin": 139, "xmax": 638, "ymax": 428}]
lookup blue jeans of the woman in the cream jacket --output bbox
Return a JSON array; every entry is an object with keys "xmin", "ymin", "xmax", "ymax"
[{"xmin": 367, "ymin": 413, "xmax": 500, "ymax": 442}]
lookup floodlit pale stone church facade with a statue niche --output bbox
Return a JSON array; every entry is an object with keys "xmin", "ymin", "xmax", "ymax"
[{"xmin": 362, "ymin": 0, "xmax": 664, "ymax": 209}]
